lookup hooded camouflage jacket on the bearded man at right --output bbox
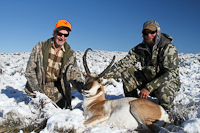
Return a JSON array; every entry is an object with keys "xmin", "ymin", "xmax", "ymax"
[{"xmin": 106, "ymin": 33, "xmax": 180, "ymax": 92}]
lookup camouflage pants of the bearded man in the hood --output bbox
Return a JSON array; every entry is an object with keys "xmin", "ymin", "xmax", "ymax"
[{"xmin": 121, "ymin": 68, "xmax": 179, "ymax": 109}]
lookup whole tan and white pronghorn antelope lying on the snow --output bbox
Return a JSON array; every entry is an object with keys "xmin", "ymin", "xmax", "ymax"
[{"xmin": 82, "ymin": 48, "xmax": 170, "ymax": 130}]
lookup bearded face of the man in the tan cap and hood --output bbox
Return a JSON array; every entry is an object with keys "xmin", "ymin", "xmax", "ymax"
[{"xmin": 143, "ymin": 29, "xmax": 157, "ymax": 46}]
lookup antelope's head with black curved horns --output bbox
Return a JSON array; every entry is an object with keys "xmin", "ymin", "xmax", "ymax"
[{"xmin": 82, "ymin": 48, "xmax": 115, "ymax": 99}]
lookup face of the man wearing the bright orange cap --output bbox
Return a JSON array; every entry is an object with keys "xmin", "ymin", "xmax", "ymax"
[{"xmin": 53, "ymin": 29, "xmax": 69, "ymax": 47}]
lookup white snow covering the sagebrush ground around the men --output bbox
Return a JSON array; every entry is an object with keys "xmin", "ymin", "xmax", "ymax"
[{"xmin": 0, "ymin": 50, "xmax": 200, "ymax": 133}]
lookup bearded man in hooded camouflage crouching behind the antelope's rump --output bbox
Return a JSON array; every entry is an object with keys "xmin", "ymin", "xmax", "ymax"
[{"xmin": 106, "ymin": 20, "xmax": 180, "ymax": 109}]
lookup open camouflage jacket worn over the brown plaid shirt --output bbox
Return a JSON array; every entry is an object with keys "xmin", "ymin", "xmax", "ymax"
[{"xmin": 25, "ymin": 38, "xmax": 83, "ymax": 104}]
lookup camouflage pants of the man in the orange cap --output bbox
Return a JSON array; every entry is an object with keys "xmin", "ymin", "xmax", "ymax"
[{"xmin": 39, "ymin": 82, "xmax": 63, "ymax": 103}]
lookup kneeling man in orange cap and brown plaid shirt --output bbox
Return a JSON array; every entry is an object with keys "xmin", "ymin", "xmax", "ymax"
[{"xmin": 25, "ymin": 20, "xmax": 83, "ymax": 109}]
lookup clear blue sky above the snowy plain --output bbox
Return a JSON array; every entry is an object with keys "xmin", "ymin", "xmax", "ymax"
[{"xmin": 0, "ymin": 0, "xmax": 200, "ymax": 54}]
